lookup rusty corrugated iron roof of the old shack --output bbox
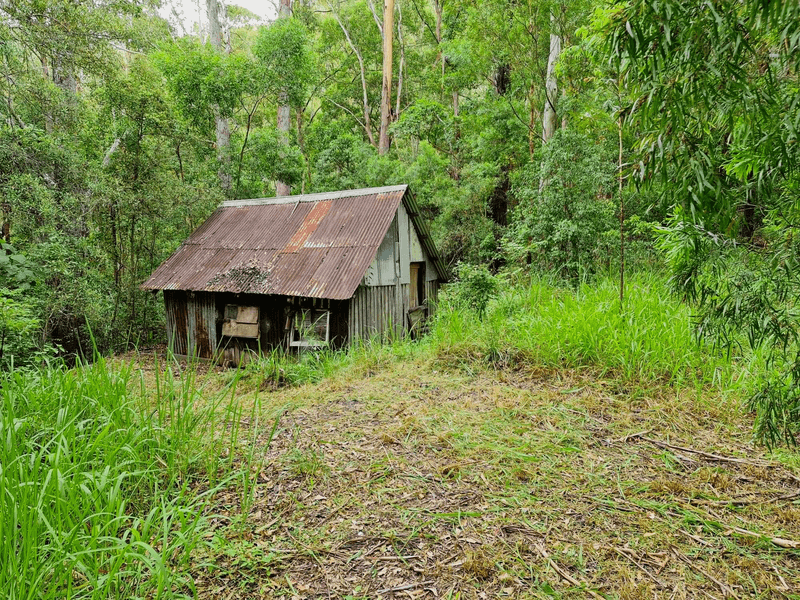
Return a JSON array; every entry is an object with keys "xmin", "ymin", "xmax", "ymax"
[{"xmin": 142, "ymin": 185, "xmax": 446, "ymax": 300}]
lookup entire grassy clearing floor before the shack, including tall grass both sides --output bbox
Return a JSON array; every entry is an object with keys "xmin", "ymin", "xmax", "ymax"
[{"xmin": 0, "ymin": 278, "xmax": 800, "ymax": 599}]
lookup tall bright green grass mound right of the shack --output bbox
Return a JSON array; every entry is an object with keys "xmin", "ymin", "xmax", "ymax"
[{"xmin": 428, "ymin": 273, "xmax": 756, "ymax": 387}]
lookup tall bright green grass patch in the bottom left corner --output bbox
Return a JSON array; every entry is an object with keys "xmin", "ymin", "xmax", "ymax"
[{"xmin": 0, "ymin": 360, "xmax": 260, "ymax": 599}]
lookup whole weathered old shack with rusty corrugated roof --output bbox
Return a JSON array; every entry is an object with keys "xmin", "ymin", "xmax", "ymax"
[{"xmin": 142, "ymin": 185, "xmax": 447, "ymax": 363}]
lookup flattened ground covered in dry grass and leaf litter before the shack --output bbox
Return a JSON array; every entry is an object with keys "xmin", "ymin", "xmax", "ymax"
[{"xmin": 128, "ymin": 352, "xmax": 800, "ymax": 599}]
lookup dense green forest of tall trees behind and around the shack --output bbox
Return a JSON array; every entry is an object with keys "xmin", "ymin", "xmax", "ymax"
[{"xmin": 0, "ymin": 0, "xmax": 800, "ymax": 437}]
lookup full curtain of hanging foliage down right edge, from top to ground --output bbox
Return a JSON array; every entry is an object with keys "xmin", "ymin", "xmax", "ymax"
[{"xmin": 603, "ymin": 0, "xmax": 800, "ymax": 445}]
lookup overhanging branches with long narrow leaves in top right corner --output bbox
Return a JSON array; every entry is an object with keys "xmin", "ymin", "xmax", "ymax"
[{"xmin": 607, "ymin": 0, "xmax": 800, "ymax": 230}]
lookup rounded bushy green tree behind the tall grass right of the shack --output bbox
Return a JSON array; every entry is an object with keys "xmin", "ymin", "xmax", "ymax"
[{"xmin": 507, "ymin": 131, "xmax": 615, "ymax": 280}]
